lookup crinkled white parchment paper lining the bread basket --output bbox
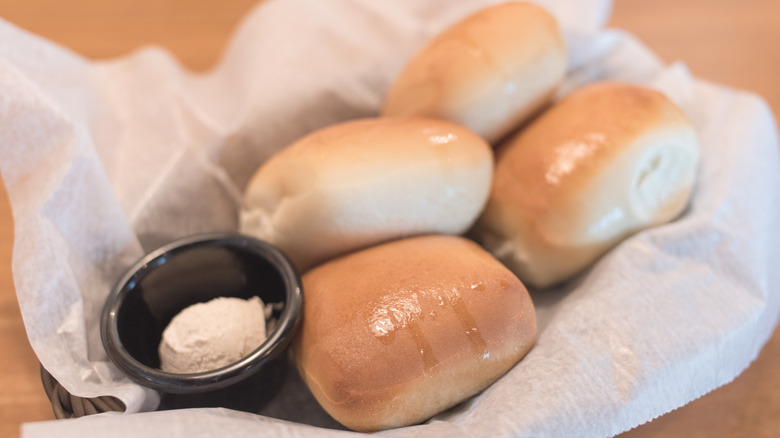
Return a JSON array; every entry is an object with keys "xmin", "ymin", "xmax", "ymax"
[{"xmin": 0, "ymin": 0, "xmax": 780, "ymax": 438}]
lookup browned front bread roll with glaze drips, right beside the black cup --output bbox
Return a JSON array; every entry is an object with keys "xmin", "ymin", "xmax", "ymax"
[{"xmin": 294, "ymin": 235, "xmax": 536, "ymax": 431}]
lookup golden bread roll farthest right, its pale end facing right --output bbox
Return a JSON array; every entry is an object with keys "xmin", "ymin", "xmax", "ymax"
[{"xmin": 473, "ymin": 83, "xmax": 699, "ymax": 287}]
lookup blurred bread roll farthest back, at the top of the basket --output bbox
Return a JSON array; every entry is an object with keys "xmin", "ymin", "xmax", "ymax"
[{"xmin": 382, "ymin": 2, "xmax": 567, "ymax": 143}]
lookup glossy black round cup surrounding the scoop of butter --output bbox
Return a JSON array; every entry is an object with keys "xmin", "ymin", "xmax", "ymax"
[{"xmin": 101, "ymin": 233, "xmax": 303, "ymax": 394}]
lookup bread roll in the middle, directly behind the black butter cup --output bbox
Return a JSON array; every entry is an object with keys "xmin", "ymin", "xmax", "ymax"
[{"xmin": 241, "ymin": 119, "xmax": 493, "ymax": 271}]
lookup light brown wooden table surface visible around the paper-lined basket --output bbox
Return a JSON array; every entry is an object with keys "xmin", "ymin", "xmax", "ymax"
[{"xmin": 0, "ymin": 0, "xmax": 780, "ymax": 438}]
